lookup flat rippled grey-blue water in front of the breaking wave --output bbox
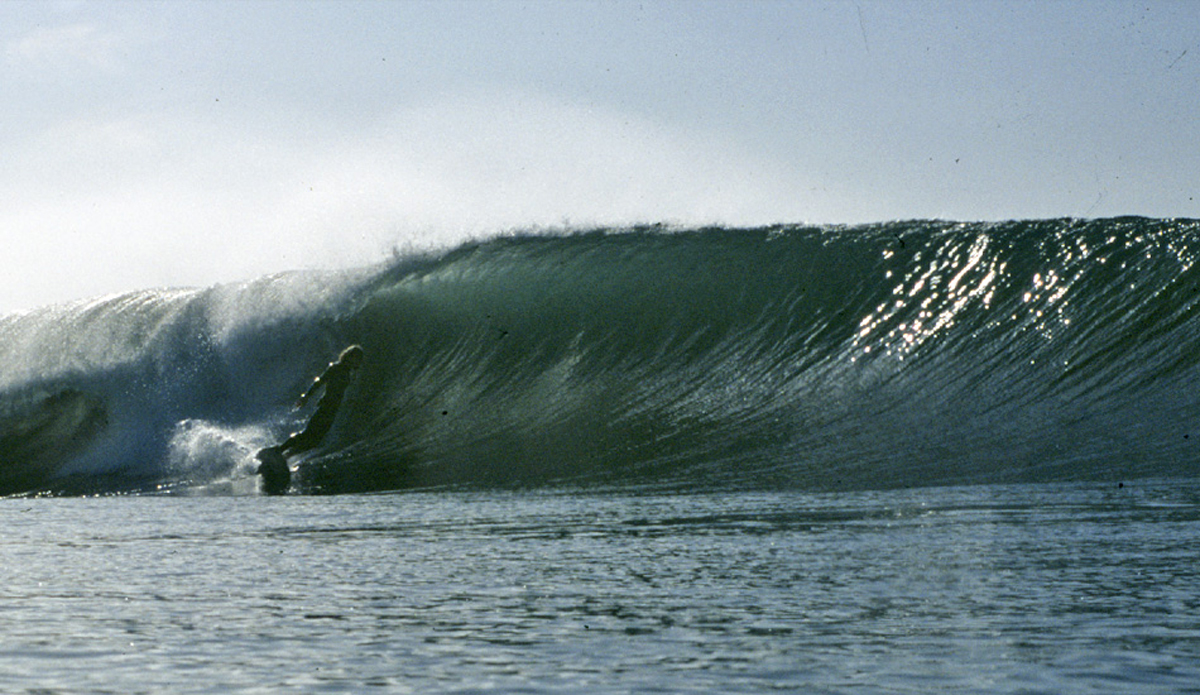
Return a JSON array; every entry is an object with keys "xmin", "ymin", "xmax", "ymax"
[{"xmin": 0, "ymin": 480, "xmax": 1200, "ymax": 695}]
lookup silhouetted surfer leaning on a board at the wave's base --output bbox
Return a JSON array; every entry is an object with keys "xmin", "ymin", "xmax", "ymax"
[{"xmin": 258, "ymin": 344, "xmax": 362, "ymax": 495}]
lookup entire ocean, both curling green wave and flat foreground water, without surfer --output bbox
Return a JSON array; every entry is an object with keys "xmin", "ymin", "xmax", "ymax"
[{"xmin": 0, "ymin": 217, "xmax": 1200, "ymax": 693}]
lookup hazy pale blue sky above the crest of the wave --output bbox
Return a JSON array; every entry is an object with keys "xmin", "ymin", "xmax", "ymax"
[{"xmin": 0, "ymin": 0, "xmax": 1200, "ymax": 314}]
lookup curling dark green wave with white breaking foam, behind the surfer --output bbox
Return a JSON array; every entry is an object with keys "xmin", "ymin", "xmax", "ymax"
[{"xmin": 0, "ymin": 218, "xmax": 1200, "ymax": 493}]
